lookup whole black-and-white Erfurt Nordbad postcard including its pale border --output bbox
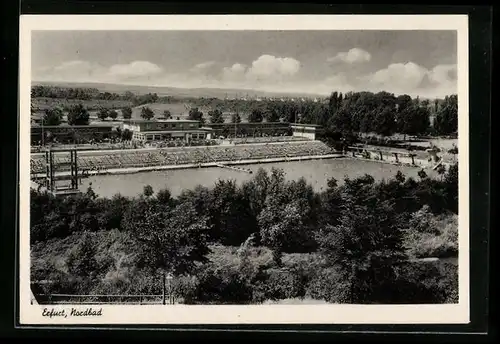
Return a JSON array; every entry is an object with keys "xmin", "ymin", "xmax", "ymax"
[{"xmin": 20, "ymin": 15, "xmax": 469, "ymax": 324}]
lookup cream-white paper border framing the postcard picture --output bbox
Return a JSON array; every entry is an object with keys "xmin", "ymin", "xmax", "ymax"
[{"xmin": 19, "ymin": 15, "xmax": 469, "ymax": 325}]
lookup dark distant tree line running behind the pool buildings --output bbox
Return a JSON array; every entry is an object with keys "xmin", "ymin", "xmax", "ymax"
[{"xmin": 32, "ymin": 86, "xmax": 458, "ymax": 136}]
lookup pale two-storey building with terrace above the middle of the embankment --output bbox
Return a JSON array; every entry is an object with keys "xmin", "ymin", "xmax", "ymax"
[{"xmin": 123, "ymin": 119, "xmax": 212, "ymax": 142}]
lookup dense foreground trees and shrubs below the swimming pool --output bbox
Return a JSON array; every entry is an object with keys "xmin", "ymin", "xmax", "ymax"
[{"xmin": 30, "ymin": 164, "xmax": 458, "ymax": 304}]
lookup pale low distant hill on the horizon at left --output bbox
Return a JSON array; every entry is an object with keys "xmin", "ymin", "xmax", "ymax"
[{"xmin": 31, "ymin": 81, "xmax": 323, "ymax": 99}]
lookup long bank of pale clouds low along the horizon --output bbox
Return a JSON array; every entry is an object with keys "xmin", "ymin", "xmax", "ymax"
[{"xmin": 33, "ymin": 55, "xmax": 457, "ymax": 97}]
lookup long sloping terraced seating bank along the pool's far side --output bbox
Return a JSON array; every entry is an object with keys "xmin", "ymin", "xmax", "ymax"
[{"xmin": 31, "ymin": 141, "xmax": 333, "ymax": 173}]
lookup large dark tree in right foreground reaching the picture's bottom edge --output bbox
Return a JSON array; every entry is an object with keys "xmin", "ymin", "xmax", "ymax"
[{"xmin": 318, "ymin": 187, "xmax": 406, "ymax": 303}]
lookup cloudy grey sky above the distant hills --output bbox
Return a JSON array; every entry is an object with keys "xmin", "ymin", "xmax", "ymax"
[{"xmin": 31, "ymin": 30, "xmax": 457, "ymax": 98}]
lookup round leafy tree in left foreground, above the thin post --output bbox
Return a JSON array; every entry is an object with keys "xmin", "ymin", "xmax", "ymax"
[{"xmin": 131, "ymin": 203, "xmax": 210, "ymax": 275}]
